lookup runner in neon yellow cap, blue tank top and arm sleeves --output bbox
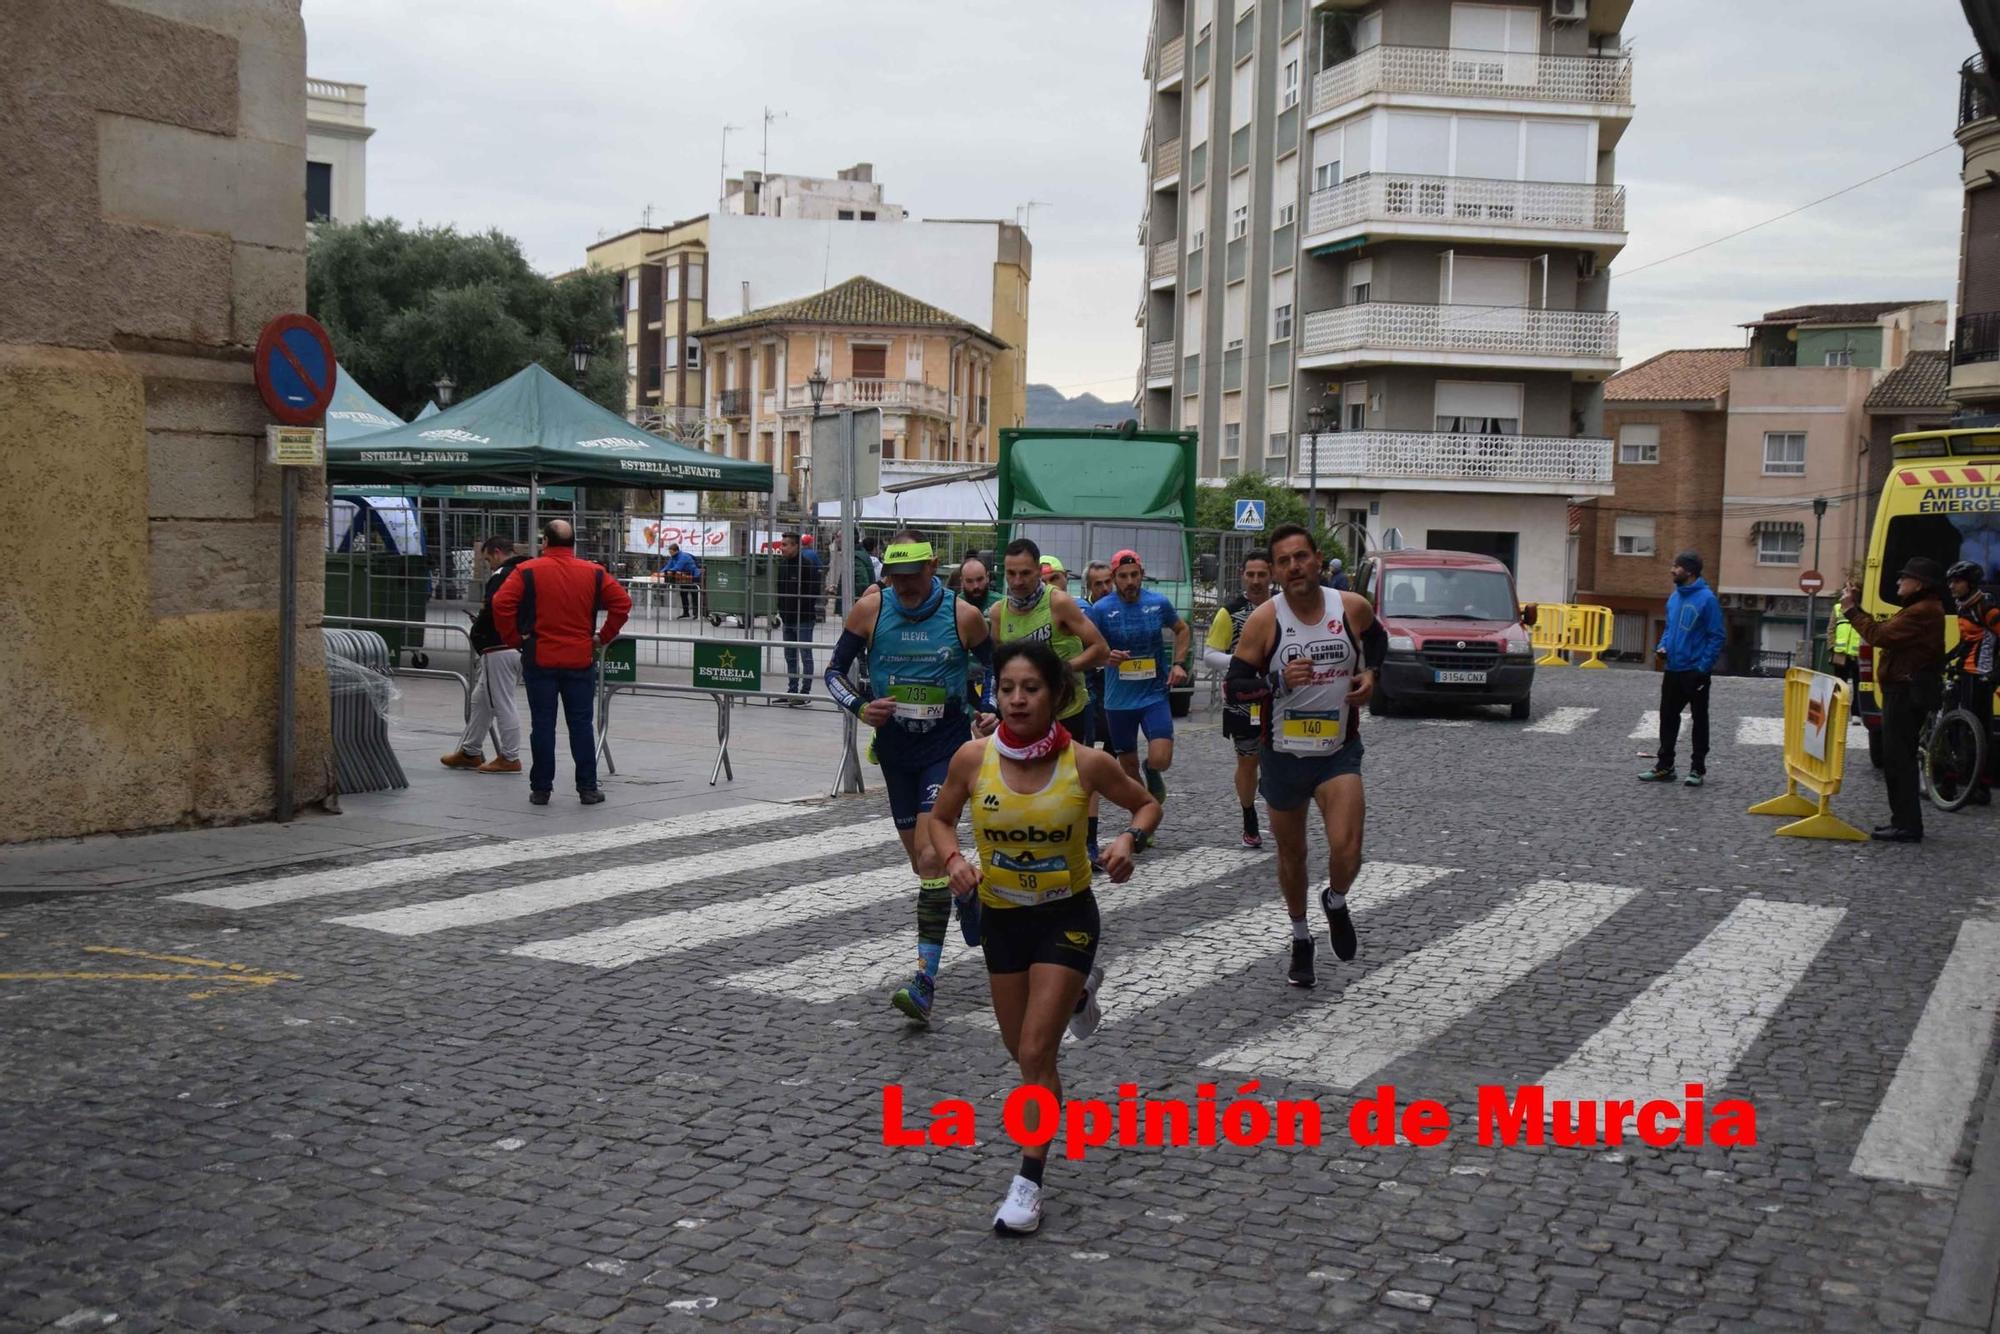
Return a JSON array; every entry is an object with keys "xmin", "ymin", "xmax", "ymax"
[{"xmin": 826, "ymin": 532, "xmax": 992, "ymax": 1024}]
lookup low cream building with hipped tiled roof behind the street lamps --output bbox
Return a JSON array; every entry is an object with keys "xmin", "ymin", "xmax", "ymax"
[{"xmin": 702, "ymin": 278, "xmax": 1006, "ymax": 496}]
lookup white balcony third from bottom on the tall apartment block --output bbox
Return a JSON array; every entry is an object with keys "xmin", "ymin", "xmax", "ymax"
[{"xmin": 1304, "ymin": 172, "xmax": 1626, "ymax": 260}]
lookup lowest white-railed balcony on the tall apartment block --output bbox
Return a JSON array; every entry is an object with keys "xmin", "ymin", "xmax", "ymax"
[{"xmin": 1292, "ymin": 430, "xmax": 1612, "ymax": 496}]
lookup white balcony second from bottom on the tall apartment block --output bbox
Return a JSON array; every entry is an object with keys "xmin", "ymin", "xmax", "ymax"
[{"xmin": 1298, "ymin": 302, "xmax": 1618, "ymax": 376}]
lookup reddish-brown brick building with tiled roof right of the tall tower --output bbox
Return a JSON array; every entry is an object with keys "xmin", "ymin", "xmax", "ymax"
[{"xmin": 1576, "ymin": 348, "xmax": 1744, "ymax": 660}]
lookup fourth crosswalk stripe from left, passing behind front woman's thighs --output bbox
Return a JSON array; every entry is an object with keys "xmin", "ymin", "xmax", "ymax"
[{"xmin": 722, "ymin": 848, "xmax": 1270, "ymax": 1004}]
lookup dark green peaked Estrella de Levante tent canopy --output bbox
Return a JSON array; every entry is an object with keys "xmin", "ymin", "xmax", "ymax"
[{"xmin": 326, "ymin": 366, "xmax": 772, "ymax": 492}]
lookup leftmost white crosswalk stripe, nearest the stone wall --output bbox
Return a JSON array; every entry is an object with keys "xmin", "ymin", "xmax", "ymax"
[{"xmin": 172, "ymin": 802, "xmax": 808, "ymax": 910}]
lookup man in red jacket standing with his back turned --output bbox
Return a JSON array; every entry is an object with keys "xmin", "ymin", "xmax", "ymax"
[{"xmin": 494, "ymin": 518, "xmax": 632, "ymax": 806}]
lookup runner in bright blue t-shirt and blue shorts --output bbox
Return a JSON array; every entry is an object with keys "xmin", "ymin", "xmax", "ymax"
[{"xmin": 1090, "ymin": 550, "xmax": 1192, "ymax": 850}]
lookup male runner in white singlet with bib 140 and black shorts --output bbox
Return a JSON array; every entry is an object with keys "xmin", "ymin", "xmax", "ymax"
[{"xmin": 1224, "ymin": 524, "xmax": 1388, "ymax": 986}]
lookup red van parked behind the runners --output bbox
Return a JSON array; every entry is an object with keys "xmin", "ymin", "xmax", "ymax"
[{"xmin": 1356, "ymin": 552, "xmax": 1534, "ymax": 718}]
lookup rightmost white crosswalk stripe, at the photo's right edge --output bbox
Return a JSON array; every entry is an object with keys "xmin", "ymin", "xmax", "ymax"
[{"xmin": 1852, "ymin": 922, "xmax": 2000, "ymax": 1186}]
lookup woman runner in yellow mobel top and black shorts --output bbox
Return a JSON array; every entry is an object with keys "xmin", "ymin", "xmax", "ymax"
[{"xmin": 924, "ymin": 640, "xmax": 1160, "ymax": 1236}]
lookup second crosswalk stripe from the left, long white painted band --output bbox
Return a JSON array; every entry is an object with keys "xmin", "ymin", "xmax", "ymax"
[{"xmin": 328, "ymin": 820, "xmax": 896, "ymax": 936}]
